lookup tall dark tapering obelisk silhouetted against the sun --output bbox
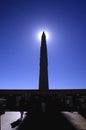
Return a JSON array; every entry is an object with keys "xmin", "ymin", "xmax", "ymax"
[{"xmin": 39, "ymin": 32, "xmax": 49, "ymax": 90}]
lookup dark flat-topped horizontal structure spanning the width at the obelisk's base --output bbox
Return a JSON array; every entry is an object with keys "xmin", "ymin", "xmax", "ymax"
[{"xmin": 0, "ymin": 90, "xmax": 86, "ymax": 116}]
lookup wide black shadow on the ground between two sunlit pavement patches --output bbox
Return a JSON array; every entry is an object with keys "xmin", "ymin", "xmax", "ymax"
[{"xmin": 16, "ymin": 112, "xmax": 77, "ymax": 130}]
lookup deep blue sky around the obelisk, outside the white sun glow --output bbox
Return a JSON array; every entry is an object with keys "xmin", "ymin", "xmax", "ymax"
[{"xmin": 0, "ymin": 0, "xmax": 86, "ymax": 89}]
